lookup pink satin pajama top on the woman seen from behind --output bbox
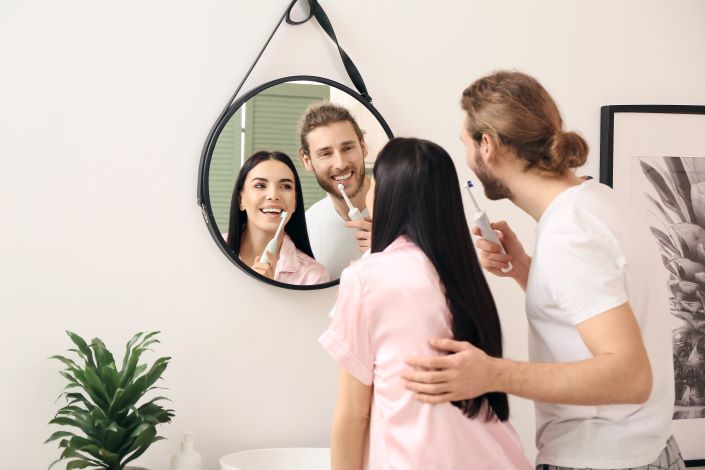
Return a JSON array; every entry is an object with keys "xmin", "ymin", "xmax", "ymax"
[{"xmin": 319, "ymin": 237, "xmax": 532, "ymax": 470}]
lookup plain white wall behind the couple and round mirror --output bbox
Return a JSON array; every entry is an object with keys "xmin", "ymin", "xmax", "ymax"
[{"xmin": 0, "ymin": 0, "xmax": 705, "ymax": 470}]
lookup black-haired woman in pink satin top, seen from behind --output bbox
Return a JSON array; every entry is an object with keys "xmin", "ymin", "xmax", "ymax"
[{"xmin": 319, "ymin": 138, "xmax": 532, "ymax": 470}]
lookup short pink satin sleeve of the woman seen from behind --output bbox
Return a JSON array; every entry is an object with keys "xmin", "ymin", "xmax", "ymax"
[{"xmin": 318, "ymin": 267, "xmax": 373, "ymax": 385}]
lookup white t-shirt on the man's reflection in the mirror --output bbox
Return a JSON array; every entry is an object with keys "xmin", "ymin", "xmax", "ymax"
[{"xmin": 306, "ymin": 196, "xmax": 368, "ymax": 280}]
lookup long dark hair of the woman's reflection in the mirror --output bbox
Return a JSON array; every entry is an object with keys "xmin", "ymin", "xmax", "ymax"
[{"xmin": 226, "ymin": 150, "xmax": 313, "ymax": 258}]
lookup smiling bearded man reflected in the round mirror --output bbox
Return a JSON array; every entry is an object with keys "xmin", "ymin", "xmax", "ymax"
[{"xmin": 299, "ymin": 102, "xmax": 371, "ymax": 279}]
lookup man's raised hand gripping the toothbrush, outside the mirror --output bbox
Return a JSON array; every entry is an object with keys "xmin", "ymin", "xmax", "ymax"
[{"xmin": 472, "ymin": 220, "xmax": 531, "ymax": 290}]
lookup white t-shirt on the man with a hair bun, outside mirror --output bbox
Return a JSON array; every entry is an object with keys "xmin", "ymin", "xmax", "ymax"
[{"xmin": 526, "ymin": 181, "xmax": 675, "ymax": 468}]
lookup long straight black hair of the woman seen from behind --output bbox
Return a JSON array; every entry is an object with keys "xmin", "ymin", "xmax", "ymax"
[{"xmin": 372, "ymin": 138, "xmax": 509, "ymax": 421}]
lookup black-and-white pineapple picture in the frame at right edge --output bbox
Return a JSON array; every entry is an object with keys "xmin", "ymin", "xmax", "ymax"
[{"xmin": 639, "ymin": 157, "xmax": 705, "ymax": 419}]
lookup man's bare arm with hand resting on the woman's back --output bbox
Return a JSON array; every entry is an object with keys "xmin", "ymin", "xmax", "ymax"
[{"xmin": 408, "ymin": 302, "xmax": 653, "ymax": 406}]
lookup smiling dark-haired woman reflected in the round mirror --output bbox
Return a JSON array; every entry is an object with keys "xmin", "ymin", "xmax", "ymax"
[{"xmin": 225, "ymin": 150, "xmax": 330, "ymax": 285}]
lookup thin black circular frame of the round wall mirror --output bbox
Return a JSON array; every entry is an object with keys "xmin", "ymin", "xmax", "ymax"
[{"xmin": 198, "ymin": 75, "xmax": 394, "ymax": 290}]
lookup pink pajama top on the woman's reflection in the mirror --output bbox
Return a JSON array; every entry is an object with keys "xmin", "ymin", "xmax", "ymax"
[{"xmin": 274, "ymin": 232, "xmax": 330, "ymax": 286}]
